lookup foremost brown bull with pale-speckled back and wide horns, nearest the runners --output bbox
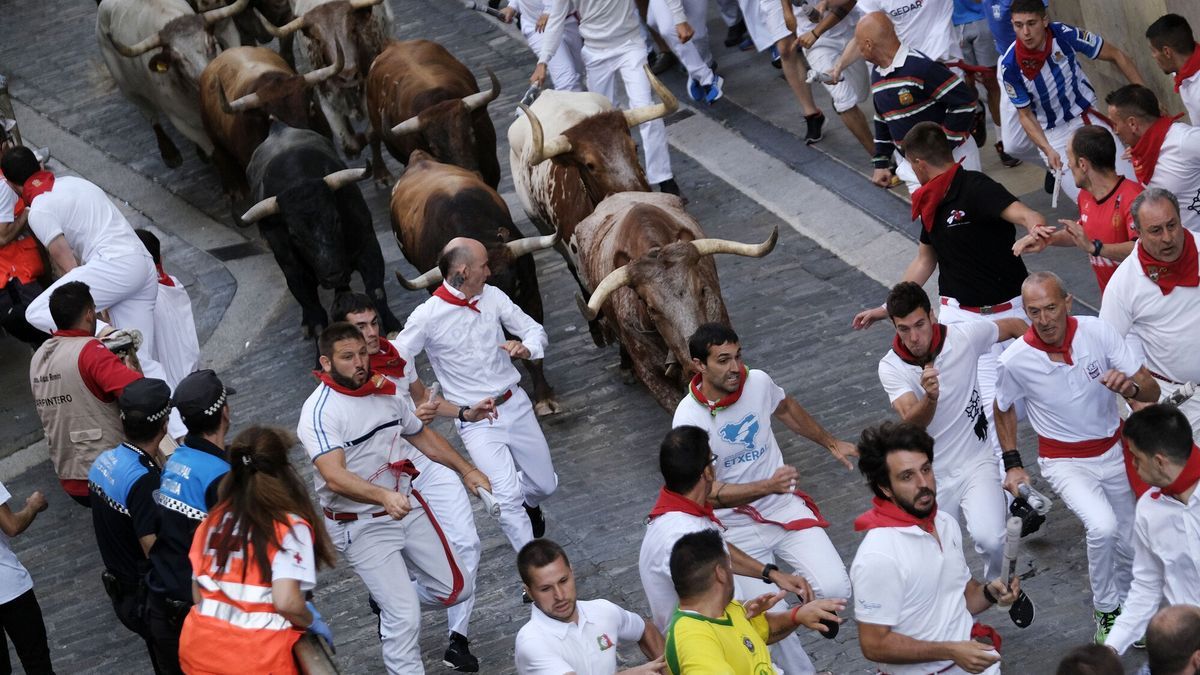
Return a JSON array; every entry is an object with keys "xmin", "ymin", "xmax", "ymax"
[{"xmin": 575, "ymin": 192, "xmax": 779, "ymax": 411}]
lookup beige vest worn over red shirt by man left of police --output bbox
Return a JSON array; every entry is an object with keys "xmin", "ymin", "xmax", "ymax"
[{"xmin": 29, "ymin": 336, "xmax": 125, "ymax": 480}]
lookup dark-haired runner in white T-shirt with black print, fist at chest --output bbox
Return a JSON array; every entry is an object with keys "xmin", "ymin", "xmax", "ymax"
[{"xmin": 880, "ymin": 281, "xmax": 1026, "ymax": 578}]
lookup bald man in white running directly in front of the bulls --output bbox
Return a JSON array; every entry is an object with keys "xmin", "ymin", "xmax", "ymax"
[{"xmin": 394, "ymin": 237, "xmax": 558, "ymax": 551}]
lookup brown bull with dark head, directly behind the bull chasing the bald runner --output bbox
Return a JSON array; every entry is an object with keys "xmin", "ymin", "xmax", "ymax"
[{"xmin": 367, "ymin": 40, "xmax": 500, "ymax": 187}]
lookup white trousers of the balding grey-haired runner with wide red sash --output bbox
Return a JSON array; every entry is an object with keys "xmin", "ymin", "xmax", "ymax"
[{"xmin": 1038, "ymin": 441, "xmax": 1136, "ymax": 611}]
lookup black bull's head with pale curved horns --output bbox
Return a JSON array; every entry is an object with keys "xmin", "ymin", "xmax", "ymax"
[{"xmin": 241, "ymin": 166, "xmax": 371, "ymax": 288}]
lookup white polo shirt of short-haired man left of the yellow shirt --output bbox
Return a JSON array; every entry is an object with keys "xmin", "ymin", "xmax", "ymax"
[{"xmin": 515, "ymin": 599, "xmax": 646, "ymax": 675}]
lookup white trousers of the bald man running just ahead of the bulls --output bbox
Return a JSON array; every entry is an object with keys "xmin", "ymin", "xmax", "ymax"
[{"xmin": 455, "ymin": 387, "xmax": 558, "ymax": 551}]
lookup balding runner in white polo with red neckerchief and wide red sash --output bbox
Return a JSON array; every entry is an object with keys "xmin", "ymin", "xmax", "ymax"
[{"xmin": 995, "ymin": 271, "xmax": 1159, "ymax": 644}]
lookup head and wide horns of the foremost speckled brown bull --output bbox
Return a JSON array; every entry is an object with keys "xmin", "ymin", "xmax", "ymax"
[{"xmin": 576, "ymin": 227, "xmax": 779, "ymax": 379}]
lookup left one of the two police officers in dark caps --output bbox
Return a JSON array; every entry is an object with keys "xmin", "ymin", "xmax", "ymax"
[{"xmin": 88, "ymin": 378, "xmax": 170, "ymax": 673}]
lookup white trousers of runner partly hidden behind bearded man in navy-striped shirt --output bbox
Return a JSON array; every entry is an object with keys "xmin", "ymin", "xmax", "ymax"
[{"xmin": 413, "ymin": 461, "xmax": 480, "ymax": 637}]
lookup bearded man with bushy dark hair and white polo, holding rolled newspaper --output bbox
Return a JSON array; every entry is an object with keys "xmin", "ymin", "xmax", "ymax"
[{"xmin": 850, "ymin": 422, "xmax": 1021, "ymax": 675}]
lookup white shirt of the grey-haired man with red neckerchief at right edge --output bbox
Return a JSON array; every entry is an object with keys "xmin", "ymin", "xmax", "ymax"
[{"xmin": 1100, "ymin": 239, "xmax": 1200, "ymax": 382}]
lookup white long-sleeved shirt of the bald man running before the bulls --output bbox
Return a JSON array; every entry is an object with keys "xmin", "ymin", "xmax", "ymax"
[{"xmin": 395, "ymin": 285, "xmax": 547, "ymax": 406}]
